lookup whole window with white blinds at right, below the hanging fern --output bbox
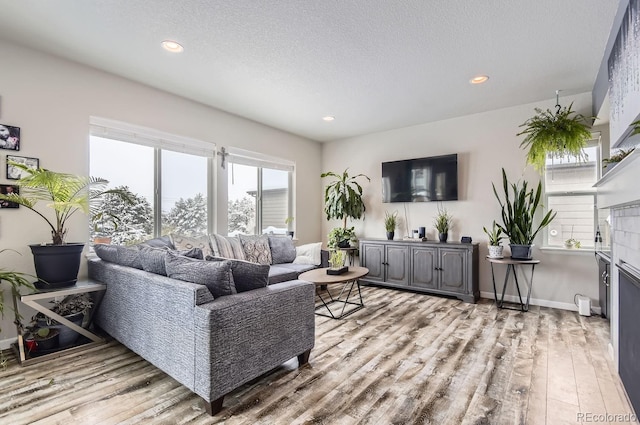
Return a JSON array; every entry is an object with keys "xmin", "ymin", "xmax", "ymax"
[{"xmin": 544, "ymin": 140, "xmax": 600, "ymax": 249}]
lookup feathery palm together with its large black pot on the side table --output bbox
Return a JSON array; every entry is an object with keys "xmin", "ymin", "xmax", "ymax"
[{"xmin": 0, "ymin": 161, "xmax": 128, "ymax": 288}]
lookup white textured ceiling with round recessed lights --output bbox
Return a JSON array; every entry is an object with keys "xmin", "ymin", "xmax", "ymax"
[{"xmin": 0, "ymin": 0, "xmax": 618, "ymax": 141}]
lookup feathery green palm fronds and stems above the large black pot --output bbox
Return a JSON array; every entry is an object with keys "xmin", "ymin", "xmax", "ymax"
[{"xmin": 0, "ymin": 161, "xmax": 128, "ymax": 245}]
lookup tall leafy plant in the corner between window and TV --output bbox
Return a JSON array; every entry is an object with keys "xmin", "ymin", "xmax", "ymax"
[{"xmin": 320, "ymin": 168, "xmax": 371, "ymax": 242}]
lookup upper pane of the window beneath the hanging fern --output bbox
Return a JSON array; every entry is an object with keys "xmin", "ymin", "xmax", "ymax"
[{"xmin": 545, "ymin": 146, "xmax": 599, "ymax": 193}]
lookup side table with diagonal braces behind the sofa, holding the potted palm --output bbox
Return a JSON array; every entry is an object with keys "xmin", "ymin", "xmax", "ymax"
[{"xmin": 11, "ymin": 281, "xmax": 107, "ymax": 366}]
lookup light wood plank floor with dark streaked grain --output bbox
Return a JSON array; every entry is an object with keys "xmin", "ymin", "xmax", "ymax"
[{"xmin": 0, "ymin": 287, "xmax": 631, "ymax": 425}]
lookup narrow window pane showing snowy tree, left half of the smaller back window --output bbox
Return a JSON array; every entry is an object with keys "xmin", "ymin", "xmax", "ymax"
[{"xmin": 227, "ymin": 163, "xmax": 258, "ymax": 236}]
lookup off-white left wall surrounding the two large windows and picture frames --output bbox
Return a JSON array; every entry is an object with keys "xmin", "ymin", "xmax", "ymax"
[{"xmin": 0, "ymin": 42, "xmax": 322, "ymax": 347}]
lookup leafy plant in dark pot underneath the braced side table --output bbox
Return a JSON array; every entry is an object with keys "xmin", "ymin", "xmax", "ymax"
[{"xmin": 32, "ymin": 294, "xmax": 93, "ymax": 347}]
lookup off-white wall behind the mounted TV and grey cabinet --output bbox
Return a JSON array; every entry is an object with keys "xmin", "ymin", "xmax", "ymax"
[{"xmin": 322, "ymin": 93, "xmax": 598, "ymax": 308}]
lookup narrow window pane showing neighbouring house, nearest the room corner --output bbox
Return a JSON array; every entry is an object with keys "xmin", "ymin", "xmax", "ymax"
[{"xmin": 262, "ymin": 168, "xmax": 289, "ymax": 235}]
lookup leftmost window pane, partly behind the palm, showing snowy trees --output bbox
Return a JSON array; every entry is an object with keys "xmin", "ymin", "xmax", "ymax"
[{"xmin": 89, "ymin": 136, "xmax": 154, "ymax": 244}]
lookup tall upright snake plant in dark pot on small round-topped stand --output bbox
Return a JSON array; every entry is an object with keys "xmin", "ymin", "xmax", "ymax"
[{"xmin": 491, "ymin": 168, "xmax": 556, "ymax": 260}]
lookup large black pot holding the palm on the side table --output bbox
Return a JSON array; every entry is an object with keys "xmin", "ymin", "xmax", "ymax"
[{"xmin": 29, "ymin": 243, "xmax": 84, "ymax": 289}]
